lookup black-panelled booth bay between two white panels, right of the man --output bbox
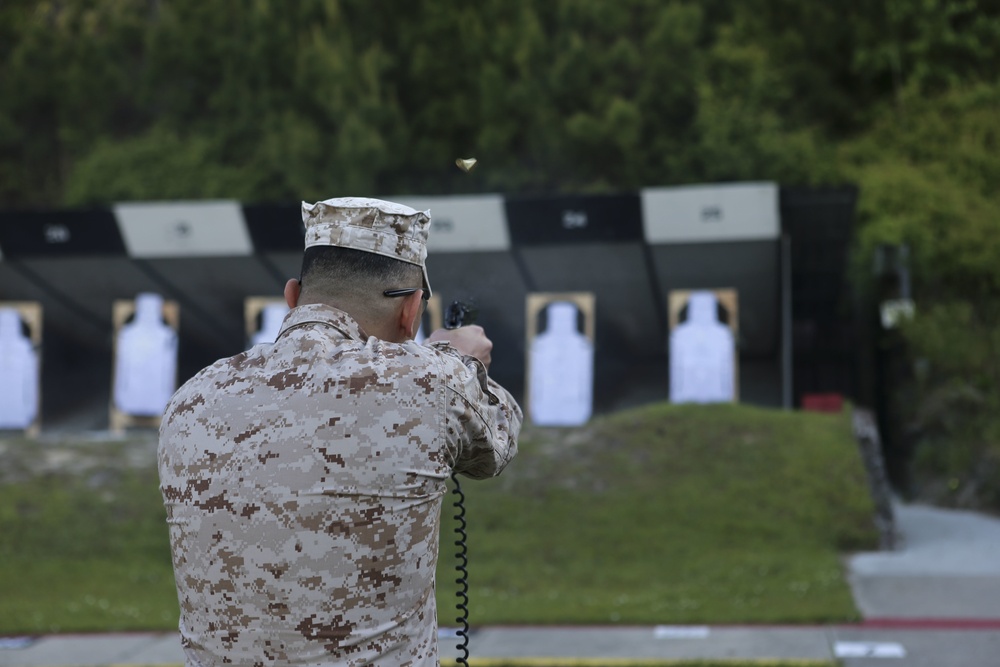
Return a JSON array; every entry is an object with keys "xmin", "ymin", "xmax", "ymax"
[{"xmin": 506, "ymin": 193, "xmax": 666, "ymax": 411}]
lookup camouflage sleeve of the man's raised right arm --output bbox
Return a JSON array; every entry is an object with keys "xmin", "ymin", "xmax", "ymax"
[{"xmin": 433, "ymin": 342, "xmax": 524, "ymax": 479}]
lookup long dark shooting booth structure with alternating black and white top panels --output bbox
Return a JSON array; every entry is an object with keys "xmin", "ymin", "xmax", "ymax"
[{"xmin": 0, "ymin": 183, "xmax": 844, "ymax": 428}]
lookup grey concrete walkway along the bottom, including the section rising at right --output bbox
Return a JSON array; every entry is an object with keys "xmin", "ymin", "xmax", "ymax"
[{"xmin": 0, "ymin": 505, "xmax": 1000, "ymax": 667}]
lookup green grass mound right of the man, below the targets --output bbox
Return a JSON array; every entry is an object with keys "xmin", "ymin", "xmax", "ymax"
[{"xmin": 438, "ymin": 404, "xmax": 877, "ymax": 625}]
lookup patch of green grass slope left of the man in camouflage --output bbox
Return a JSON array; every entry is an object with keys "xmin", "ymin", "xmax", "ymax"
[{"xmin": 0, "ymin": 442, "xmax": 178, "ymax": 635}]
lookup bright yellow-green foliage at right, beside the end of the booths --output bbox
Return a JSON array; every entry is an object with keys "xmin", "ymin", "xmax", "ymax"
[{"xmin": 842, "ymin": 84, "xmax": 1000, "ymax": 510}]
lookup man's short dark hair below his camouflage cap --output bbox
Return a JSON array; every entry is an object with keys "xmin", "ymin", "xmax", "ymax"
[{"xmin": 299, "ymin": 246, "xmax": 422, "ymax": 295}]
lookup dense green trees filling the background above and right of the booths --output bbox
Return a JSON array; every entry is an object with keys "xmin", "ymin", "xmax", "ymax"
[{"xmin": 0, "ymin": 0, "xmax": 1000, "ymax": 508}]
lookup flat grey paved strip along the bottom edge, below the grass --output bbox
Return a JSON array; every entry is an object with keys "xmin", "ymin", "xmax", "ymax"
[{"xmin": 0, "ymin": 623, "xmax": 1000, "ymax": 667}]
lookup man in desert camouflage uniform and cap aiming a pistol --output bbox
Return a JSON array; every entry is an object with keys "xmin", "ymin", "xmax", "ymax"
[{"xmin": 159, "ymin": 198, "xmax": 522, "ymax": 667}]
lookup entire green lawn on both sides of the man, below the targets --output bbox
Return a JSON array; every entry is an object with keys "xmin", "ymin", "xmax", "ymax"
[{"xmin": 0, "ymin": 404, "xmax": 877, "ymax": 634}]
